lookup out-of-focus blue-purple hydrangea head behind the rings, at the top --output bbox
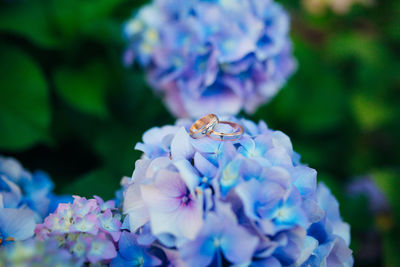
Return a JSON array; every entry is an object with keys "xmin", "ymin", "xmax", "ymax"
[{"xmin": 125, "ymin": 0, "xmax": 296, "ymax": 117}]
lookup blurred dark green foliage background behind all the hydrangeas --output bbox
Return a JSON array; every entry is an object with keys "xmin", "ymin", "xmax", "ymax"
[{"xmin": 0, "ymin": 0, "xmax": 400, "ymax": 267}]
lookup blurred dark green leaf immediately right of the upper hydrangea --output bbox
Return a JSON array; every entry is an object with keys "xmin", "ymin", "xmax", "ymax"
[{"xmin": 271, "ymin": 40, "xmax": 346, "ymax": 134}]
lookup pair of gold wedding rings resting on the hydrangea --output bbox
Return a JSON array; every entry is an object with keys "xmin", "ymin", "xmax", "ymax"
[{"xmin": 189, "ymin": 114, "xmax": 243, "ymax": 141}]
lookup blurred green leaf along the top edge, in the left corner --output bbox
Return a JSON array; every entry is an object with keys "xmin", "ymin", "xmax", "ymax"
[{"xmin": 0, "ymin": 0, "xmax": 128, "ymax": 48}]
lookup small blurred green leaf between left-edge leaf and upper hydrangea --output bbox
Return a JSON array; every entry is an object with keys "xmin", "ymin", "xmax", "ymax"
[{"xmin": 54, "ymin": 63, "xmax": 108, "ymax": 117}]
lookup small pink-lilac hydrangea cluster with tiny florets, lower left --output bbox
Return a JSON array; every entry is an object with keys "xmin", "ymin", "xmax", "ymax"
[{"xmin": 35, "ymin": 196, "xmax": 121, "ymax": 263}]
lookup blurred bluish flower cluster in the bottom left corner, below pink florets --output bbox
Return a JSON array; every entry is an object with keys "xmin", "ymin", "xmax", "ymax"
[{"xmin": 0, "ymin": 239, "xmax": 81, "ymax": 267}]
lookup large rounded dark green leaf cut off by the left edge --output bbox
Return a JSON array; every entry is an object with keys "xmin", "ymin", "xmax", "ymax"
[{"xmin": 0, "ymin": 45, "xmax": 50, "ymax": 150}]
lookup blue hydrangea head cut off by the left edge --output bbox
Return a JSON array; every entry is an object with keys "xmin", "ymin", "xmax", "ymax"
[{"xmin": 0, "ymin": 156, "xmax": 70, "ymax": 244}]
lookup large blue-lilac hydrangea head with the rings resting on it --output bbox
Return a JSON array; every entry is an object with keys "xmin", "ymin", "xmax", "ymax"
[{"xmin": 123, "ymin": 118, "xmax": 353, "ymax": 266}]
